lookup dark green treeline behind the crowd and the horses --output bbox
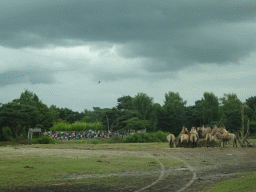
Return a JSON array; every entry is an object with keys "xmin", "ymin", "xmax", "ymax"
[{"xmin": 0, "ymin": 90, "xmax": 256, "ymax": 141}]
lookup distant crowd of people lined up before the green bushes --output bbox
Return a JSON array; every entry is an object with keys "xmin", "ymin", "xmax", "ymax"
[{"xmin": 44, "ymin": 130, "xmax": 134, "ymax": 140}]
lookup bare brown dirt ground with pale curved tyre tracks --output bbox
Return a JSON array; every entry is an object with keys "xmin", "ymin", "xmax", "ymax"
[{"xmin": 0, "ymin": 148, "xmax": 256, "ymax": 192}]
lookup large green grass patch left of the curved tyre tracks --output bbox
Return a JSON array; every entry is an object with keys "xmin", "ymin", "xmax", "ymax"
[{"xmin": 0, "ymin": 143, "xmax": 197, "ymax": 187}]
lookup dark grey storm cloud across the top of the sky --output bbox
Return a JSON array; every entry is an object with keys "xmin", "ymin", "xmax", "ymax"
[{"xmin": 0, "ymin": 0, "xmax": 256, "ymax": 72}]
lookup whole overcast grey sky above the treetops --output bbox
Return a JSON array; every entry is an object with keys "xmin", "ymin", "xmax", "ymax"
[{"xmin": 0, "ymin": 0, "xmax": 256, "ymax": 112}]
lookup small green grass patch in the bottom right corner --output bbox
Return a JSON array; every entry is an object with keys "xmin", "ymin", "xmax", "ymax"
[{"xmin": 204, "ymin": 172, "xmax": 256, "ymax": 192}]
